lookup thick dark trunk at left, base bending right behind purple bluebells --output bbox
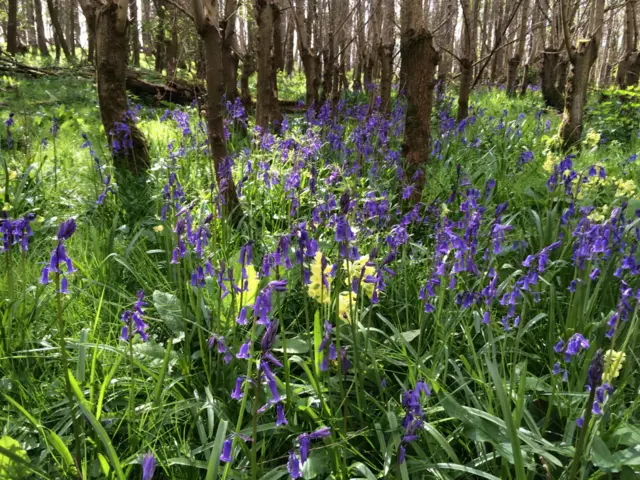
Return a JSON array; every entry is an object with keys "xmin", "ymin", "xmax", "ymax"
[{"xmin": 96, "ymin": 0, "xmax": 149, "ymax": 174}]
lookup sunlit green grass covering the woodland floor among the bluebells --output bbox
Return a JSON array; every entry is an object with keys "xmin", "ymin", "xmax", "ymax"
[{"xmin": 0, "ymin": 68, "xmax": 640, "ymax": 479}]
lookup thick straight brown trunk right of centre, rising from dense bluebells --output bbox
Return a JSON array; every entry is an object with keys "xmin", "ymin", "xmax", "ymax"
[{"xmin": 401, "ymin": 0, "xmax": 439, "ymax": 204}]
